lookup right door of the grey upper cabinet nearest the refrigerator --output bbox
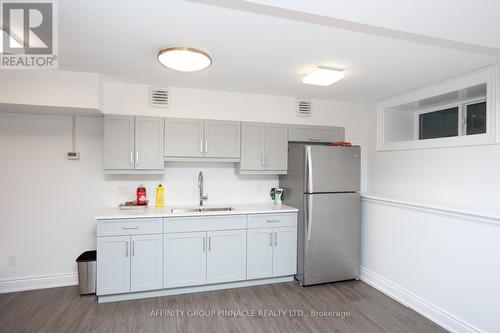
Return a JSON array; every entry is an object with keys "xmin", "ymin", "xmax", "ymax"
[{"xmin": 265, "ymin": 124, "xmax": 288, "ymax": 171}]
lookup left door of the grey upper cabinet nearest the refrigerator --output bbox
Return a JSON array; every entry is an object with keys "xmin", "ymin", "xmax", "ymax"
[{"xmin": 240, "ymin": 122, "xmax": 266, "ymax": 171}]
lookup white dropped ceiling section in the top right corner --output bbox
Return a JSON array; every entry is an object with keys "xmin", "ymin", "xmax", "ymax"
[{"xmin": 242, "ymin": 0, "xmax": 500, "ymax": 51}]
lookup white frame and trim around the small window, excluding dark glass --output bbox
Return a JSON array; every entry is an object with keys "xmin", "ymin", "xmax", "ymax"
[{"xmin": 376, "ymin": 65, "xmax": 500, "ymax": 151}]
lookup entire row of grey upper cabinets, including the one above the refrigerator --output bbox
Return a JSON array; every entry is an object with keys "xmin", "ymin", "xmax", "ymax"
[{"xmin": 104, "ymin": 115, "xmax": 345, "ymax": 175}]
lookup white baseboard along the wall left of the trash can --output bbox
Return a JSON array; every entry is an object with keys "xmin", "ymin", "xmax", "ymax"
[{"xmin": 0, "ymin": 273, "xmax": 78, "ymax": 294}]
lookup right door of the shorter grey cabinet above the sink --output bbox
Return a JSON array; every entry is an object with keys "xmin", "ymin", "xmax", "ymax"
[{"xmin": 204, "ymin": 120, "xmax": 241, "ymax": 158}]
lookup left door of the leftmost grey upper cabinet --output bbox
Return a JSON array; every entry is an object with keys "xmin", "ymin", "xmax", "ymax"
[{"xmin": 104, "ymin": 115, "xmax": 135, "ymax": 170}]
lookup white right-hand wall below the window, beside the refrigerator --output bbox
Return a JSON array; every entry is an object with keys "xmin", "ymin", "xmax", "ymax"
[{"xmin": 362, "ymin": 68, "xmax": 500, "ymax": 332}]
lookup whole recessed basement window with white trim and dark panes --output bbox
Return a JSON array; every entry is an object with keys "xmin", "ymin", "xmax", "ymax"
[{"xmin": 377, "ymin": 68, "xmax": 500, "ymax": 151}]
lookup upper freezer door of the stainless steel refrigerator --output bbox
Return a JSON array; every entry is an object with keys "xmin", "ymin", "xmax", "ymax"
[{"xmin": 305, "ymin": 146, "xmax": 360, "ymax": 193}]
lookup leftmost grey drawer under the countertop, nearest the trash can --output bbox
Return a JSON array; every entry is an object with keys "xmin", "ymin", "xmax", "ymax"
[{"xmin": 97, "ymin": 218, "xmax": 163, "ymax": 236}]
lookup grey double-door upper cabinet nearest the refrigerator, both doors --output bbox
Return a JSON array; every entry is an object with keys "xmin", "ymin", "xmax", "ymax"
[{"xmin": 240, "ymin": 122, "xmax": 288, "ymax": 174}]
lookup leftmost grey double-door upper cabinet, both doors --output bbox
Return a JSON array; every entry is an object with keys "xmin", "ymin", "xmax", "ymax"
[{"xmin": 104, "ymin": 115, "xmax": 164, "ymax": 173}]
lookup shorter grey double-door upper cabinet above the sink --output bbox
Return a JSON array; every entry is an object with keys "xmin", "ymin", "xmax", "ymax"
[{"xmin": 165, "ymin": 118, "xmax": 240, "ymax": 162}]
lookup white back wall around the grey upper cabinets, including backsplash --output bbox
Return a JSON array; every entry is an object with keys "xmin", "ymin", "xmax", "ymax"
[{"xmin": 0, "ymin": 85, "xmax": 365, "ymax": 292}]
